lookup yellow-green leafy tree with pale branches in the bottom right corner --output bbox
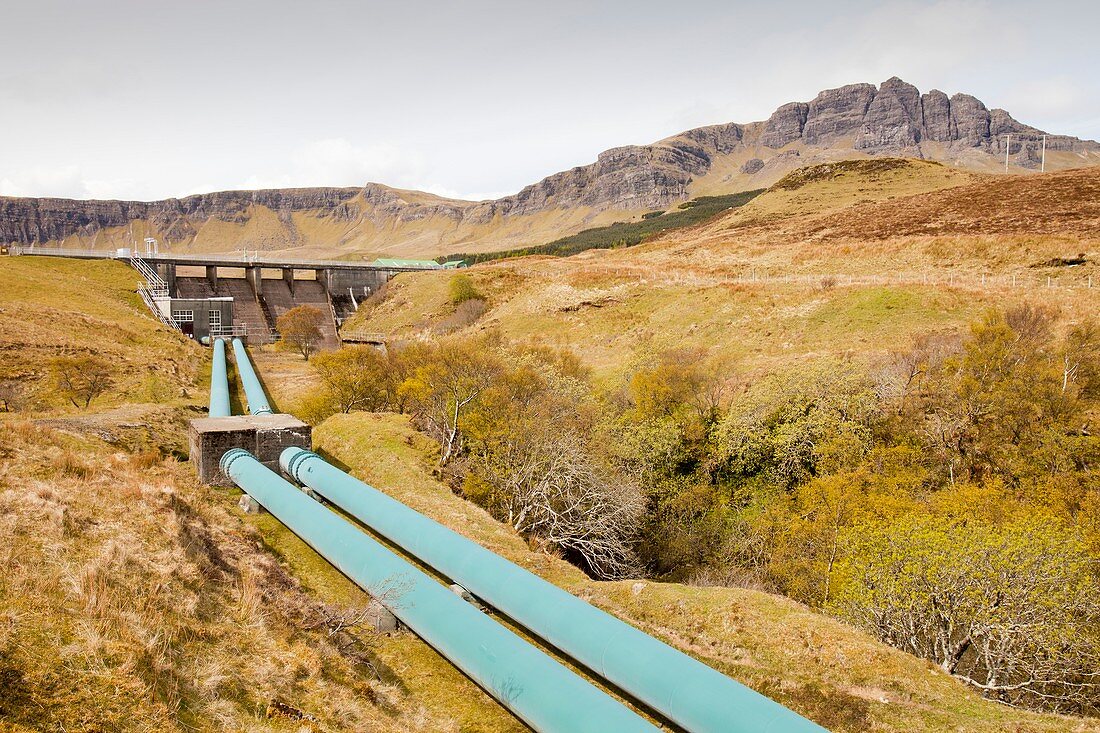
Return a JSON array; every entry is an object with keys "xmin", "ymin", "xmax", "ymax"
[{"xmin": 833, "ymin": 497, "xmax": 1100, "ymax": 712}]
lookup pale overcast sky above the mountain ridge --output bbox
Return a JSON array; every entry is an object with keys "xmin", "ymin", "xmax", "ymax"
[{"xmin": 0, "ymin": 0, "xmax": 1100, "ymax": 199}]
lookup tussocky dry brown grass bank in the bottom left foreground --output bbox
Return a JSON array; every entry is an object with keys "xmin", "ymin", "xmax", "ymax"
[{"xmin": 0, "ymin": 422, "xmax": 449, "ymax": 731}]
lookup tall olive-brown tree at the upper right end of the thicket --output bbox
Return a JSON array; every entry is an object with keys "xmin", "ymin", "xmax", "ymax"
[{"xmin": 895, "ymin": 306, "xmax": 1098, "ymax": 486}]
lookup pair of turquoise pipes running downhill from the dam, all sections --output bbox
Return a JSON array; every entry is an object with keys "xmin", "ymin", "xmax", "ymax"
[{"xmin": 210, "ymin": 341, "xmax": 824, "ymax": 733}]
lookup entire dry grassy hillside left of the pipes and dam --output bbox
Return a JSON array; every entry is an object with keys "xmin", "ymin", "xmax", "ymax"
[{"xmin": 0, "ymin": 258, "xmax": 486, "ymax": 732}]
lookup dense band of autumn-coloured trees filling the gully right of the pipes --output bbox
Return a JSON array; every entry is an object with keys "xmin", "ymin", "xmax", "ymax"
[{"xmin": 292, "ymin": 305, "xmax": 1100, "ymax": 712}]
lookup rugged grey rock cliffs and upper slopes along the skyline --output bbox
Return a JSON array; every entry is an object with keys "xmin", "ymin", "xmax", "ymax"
[{"xmin": 0, "ymin": 77, "xmax": 1100, "ymax": 254}]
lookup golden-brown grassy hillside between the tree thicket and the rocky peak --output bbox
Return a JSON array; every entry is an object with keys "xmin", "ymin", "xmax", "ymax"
[{"xmin": 338, "ymin": 161, "xmax": 1100, "ymax": 374}]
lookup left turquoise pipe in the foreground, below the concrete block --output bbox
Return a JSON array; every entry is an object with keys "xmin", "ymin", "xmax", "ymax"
[{"xmin": 221, "ymin": 448, "xmax": 658, "ymax": 733}]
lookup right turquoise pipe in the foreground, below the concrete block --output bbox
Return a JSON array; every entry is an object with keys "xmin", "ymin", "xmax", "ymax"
[{"xmin": 279, "ymin": 448, "xmax": 825, "ymax": 733}]
